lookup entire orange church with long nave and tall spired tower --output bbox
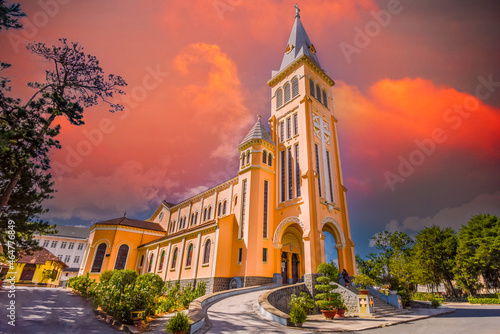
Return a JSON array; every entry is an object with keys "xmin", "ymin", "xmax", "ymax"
[{"xmin": 80, "ymin": 6, "xmax": 356, "ymax": 292}]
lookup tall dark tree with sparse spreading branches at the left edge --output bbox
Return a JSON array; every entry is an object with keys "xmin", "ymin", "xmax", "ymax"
[{"xmin": 0, "ymin": 35, "xmax": 126, "ymax": 251}]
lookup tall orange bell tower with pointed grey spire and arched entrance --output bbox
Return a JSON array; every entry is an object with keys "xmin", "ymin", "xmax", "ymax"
[{"xmin": 268, "ymin": 5, "xmax": 356, "ymax": 286}]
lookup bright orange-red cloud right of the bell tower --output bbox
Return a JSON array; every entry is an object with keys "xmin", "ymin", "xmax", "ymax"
[{"xmin": 334, "ymin": 78, "xmax": 500, "ymax": 193}]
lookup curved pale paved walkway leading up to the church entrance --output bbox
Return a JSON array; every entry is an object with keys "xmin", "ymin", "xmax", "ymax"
[{"xmin": 202, "ymin": 289, "xmax": 314, "ymax": 334}]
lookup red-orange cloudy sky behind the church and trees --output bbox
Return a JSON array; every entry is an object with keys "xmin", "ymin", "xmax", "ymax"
[{"xmin": 0, "ymin": 0, "xmax": 500, "ymax": 256}]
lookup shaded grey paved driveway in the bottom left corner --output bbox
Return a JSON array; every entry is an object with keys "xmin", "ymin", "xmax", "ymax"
[{"xmin": 0, "ymin": 286, "xmax": 117, "ymax": 334}]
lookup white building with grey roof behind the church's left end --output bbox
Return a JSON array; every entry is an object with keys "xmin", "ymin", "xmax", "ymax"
[{"xmin": 35, "ymin": 225, "xmax": 90, "ymax": 285}]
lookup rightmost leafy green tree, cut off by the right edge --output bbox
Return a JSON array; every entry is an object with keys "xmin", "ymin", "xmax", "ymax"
[{"xmin": 455, "ymin": 214, "xmax": 500, "ymax": 293}]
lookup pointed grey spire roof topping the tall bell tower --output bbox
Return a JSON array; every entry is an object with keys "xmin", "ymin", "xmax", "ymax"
[{"xmin": 279, "ymin": 4, "xmax": 321, "ymax": 72}]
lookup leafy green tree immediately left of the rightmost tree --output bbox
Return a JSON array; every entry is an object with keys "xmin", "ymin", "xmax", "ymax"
[{"xmin": 412, "ymin": 225, "xmax": 457, "ymax": 296}]
